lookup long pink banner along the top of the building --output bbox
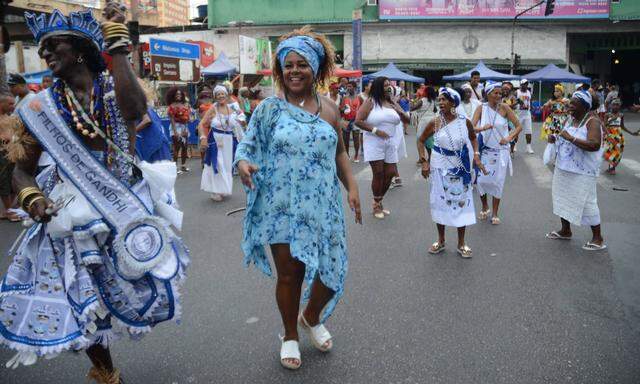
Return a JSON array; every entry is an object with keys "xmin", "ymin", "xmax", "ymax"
[{"xmin": 378, "ymin": 0, "xmax": 609, "ymax": 19}]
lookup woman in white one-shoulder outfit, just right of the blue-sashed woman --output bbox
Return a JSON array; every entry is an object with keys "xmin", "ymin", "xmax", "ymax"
[{"xmin": 473, "ymin": 81, "xmax": 522, "ymax": 225}]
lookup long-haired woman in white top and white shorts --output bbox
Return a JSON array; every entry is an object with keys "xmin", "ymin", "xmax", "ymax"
[{"xmin": 355, "ymin": 77, "xmax": 409, "ymax": 219}]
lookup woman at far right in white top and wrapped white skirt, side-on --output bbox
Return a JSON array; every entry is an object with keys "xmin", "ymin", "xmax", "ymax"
[{"xmin": 547, "ymin": 91, "xmax": 607, "ymax": 251}]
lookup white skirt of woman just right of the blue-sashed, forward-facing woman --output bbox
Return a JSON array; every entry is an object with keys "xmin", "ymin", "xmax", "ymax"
[{"xmin": 477, "ymin": 149, "xmax": 513, "ymax": 199}]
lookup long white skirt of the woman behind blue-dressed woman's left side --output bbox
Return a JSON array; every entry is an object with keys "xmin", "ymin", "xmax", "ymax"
[{"xmin": 200, "ymin": 132, "xmax": 233, "ymax": 195}]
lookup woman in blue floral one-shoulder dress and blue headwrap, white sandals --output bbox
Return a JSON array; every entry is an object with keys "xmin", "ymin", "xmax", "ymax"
[{"xmin": 235, "ymin": 28, "xmax": 361, "ymax": 369}]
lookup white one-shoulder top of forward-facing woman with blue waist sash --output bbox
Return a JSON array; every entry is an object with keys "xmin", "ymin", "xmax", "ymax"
[{"xmin": 430, "ymin": 115, "xmax": 471, "ymax": 169}]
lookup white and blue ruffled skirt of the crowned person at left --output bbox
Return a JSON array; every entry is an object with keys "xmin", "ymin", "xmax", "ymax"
[{"xmin": 0, "ymin": 162, "xmax": 189, "ymax": 367}]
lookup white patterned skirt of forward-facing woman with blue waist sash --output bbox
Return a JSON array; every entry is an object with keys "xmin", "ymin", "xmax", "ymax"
[{"xmin": 429, "ymin": 168, "xmax": 476, "ymax": 227}]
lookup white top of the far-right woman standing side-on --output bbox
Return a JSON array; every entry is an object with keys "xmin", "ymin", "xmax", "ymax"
[{"xmin": 556, "ymin": 116, "xmax": 604, "ymax": 177}]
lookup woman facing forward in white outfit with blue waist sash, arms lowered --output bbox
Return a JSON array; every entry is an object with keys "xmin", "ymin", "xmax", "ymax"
[{"xmin": 418, "ymin": 88, "xmax": 485, "ymax": 258}]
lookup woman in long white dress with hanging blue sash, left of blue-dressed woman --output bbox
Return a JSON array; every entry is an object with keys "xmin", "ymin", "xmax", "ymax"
[{"xmin": 198, "ymin": 85, "xmax": 246, "ymax": 201}]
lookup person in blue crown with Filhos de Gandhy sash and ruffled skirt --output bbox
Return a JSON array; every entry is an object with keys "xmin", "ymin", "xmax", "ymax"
[{"xmin": 0, "ymin": 2, "xmax": 188, "ymax": 384}]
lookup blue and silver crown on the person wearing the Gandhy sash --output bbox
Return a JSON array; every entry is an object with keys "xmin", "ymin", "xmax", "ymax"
[{"xmin": 24, "ymin": 9, "xmax": 104, "ymax": 51}]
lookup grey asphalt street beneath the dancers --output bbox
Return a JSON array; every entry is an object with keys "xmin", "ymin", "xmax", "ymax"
[{"xmin": 0, "ymin": 116, "xmax": 640, "ymax": 384}]
